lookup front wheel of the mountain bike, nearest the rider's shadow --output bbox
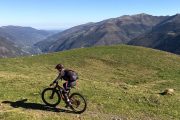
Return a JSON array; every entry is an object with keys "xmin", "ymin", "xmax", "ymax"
[{"xmin": 41, "ymin": 88, "xmax": 61, "ymax": 107}]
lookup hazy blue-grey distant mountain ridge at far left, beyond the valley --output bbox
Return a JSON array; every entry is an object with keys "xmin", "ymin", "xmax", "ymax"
[{"xmin": 0, "ymin": 26, "xmax": 53, "ymax": 46}]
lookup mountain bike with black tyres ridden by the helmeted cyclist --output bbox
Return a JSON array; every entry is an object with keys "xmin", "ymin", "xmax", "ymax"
[{"xmin": 41, "ymin": 81, "xmax": 87, "ymax": 114}]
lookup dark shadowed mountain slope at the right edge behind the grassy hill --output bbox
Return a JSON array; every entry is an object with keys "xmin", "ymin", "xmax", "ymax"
[{"xmin": 128, "ymin": 14, "xmax": 180, "ymax": 54}]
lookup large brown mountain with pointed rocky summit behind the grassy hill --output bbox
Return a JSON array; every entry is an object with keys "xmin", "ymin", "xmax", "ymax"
[{"xmin": 35, "ymin": 14, "xmax": 168, "ymax": 52}]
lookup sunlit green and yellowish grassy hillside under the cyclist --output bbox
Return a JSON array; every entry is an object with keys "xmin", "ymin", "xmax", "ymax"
[{"xmin": 0, "ymin": 45, "xmax": 180, "ymax": 120}]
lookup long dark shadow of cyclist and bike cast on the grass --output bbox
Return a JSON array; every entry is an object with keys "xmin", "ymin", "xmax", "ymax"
[{"xmin": 2, "ymin": 99, "xmax": 74, "ymax": 113}]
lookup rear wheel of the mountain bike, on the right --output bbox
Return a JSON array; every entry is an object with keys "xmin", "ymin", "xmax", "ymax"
[{"xmin": 69, "ymin": 93, "xmax": 87, "ymax": 114}]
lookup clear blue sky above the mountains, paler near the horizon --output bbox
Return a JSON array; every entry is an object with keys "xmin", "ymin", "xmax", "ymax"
[{"xmin": 0, "ymin": 0, "xmax": 180, "ymax": 29}]
